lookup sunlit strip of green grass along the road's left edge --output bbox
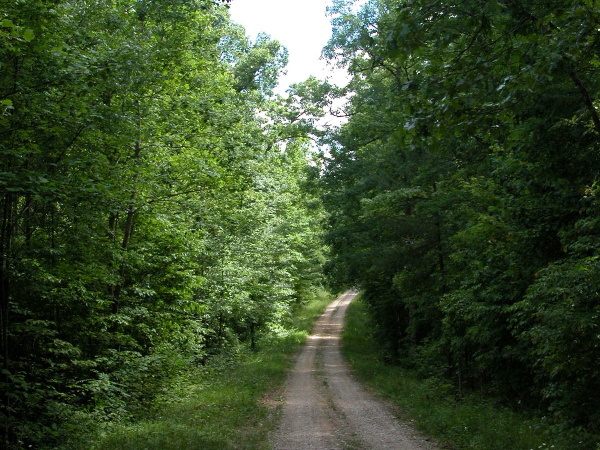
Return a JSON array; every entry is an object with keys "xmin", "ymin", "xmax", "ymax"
[{"xmin": 85, "ymin": 293, "xmax": 332, "ymax": 450}]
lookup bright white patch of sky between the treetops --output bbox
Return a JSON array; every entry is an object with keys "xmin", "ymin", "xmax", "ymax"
[{"xmin": 229, "ymin": 0, "xmax": 345, "ymax": 93}]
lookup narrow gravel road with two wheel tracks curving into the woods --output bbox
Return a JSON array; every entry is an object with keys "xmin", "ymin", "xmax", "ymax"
[{"xmin": 272, "ymin": 291, "xmax": 436, "ymax": 450}]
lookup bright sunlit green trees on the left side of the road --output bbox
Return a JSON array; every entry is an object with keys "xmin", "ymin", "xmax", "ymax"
[{"xmin": 0, "ymin": 0, "xmax": 330, "ymax": 448}]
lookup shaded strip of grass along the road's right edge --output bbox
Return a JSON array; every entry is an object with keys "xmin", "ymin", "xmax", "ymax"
[{"xmin": 342, "ymin": 298, "xmax": 600, "ymax": 450}]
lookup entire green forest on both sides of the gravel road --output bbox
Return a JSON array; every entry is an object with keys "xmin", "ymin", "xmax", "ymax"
[{"xmin": 0, "ymin": 0, "xmax": 600, "ymax": 449}]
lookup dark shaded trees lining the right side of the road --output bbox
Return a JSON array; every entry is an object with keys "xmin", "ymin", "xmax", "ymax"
[{"xmin": 324, "ymin": 0, "xmax": 600, "ymax": 440}]
